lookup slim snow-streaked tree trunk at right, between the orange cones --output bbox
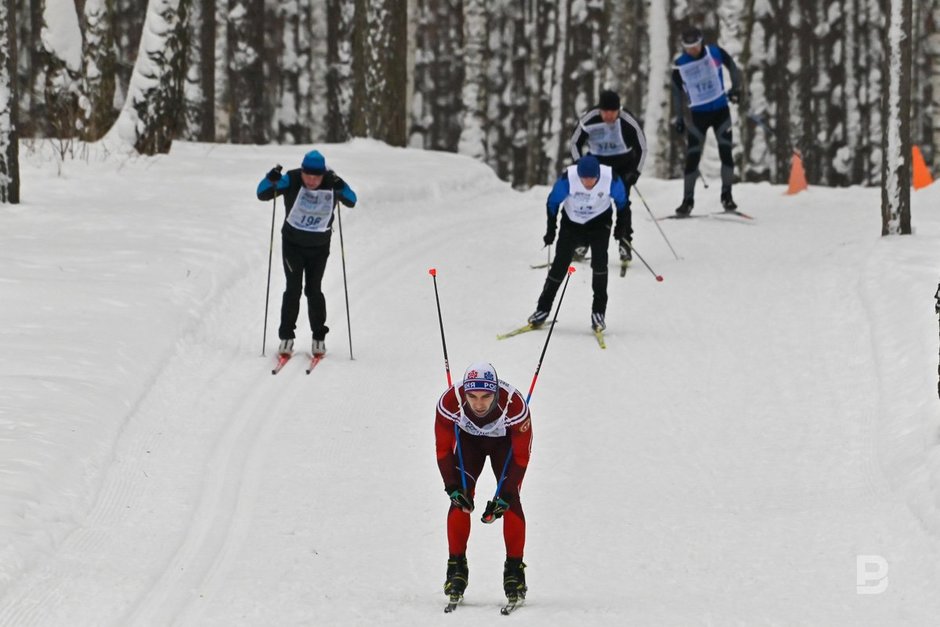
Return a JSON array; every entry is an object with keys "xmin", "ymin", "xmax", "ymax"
[{"xmin": 881, "ymin": 0, "xmax": 912, "ymax": 235}]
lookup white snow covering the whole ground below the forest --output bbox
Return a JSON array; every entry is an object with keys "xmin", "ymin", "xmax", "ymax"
[{"xmin": 0, "ymin": 140, "xmax": 940, "ymax": 626}]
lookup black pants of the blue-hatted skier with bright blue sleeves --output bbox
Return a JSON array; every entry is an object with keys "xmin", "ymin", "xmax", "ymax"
[{"xmin": 537, "ymin": 209, "xmax": 614, "ymax": 314}]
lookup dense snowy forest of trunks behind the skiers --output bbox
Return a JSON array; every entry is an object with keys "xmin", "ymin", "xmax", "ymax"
[{"xmin": 0, "ymin": 0, "xmax": 940, "ymax": 197}]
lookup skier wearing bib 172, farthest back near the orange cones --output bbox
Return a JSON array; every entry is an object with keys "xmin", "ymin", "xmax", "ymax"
[{"xmin": 672, "ymin": 28, "xmax": 741, "ymax": 217}]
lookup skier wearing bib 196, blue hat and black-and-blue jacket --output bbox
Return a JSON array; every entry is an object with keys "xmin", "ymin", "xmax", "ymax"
[{"xmin": 257, "ymin": 150, "xmax": 356, "ymax": 355}]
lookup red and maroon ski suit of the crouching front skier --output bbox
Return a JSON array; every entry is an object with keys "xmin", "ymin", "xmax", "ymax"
[{"xmin": 434, "ymin": 381, "xmax": 532, "ymax": 558}]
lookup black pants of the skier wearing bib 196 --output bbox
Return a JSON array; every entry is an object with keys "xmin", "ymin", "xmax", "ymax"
[{"xmin": 277, "ymin": 239, "xmax": 330, "ymax": 340}]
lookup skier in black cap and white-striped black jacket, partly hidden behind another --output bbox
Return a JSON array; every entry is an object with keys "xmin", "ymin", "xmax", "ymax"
[{"xmin": 570, "ymin": 90, "xmax": 646, "ymax": 261}]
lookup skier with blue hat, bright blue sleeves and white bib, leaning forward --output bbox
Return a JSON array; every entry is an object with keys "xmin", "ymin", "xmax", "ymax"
[{"xmin": 529, "ymin": 155, "xmax": 630, "ymax": 331}]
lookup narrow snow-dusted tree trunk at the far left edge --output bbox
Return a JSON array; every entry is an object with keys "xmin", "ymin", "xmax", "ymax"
[{"xmin": 0, "ymin": 0, "xmax": 20, "ymax": 204}]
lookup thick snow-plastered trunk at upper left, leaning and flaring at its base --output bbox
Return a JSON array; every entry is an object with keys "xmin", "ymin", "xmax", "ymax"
[{"xmin": 112, "ymin": 0, "xmax": 189, "ymax": 155}]
